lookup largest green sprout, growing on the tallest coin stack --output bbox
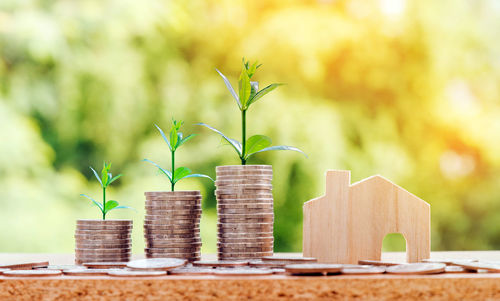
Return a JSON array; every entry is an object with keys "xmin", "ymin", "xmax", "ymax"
[{"xmin": 198, "ymin": 59, "xmax": 307, "ymax": 165}]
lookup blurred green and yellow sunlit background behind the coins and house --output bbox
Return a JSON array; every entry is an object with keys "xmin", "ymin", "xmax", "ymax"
[{"xmin": 0, "ymin": 0, "xmax": 500, "ymax": 253}]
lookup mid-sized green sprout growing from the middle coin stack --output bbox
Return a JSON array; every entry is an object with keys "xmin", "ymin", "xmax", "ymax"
[{"xmin": 143, "ymin": 119, "xmax": 213, "ymax": 191}]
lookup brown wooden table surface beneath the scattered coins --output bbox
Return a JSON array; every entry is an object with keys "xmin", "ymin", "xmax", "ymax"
[{"xmin": 0, "ymin": 251, "xmax": 500, "ymax": 300}]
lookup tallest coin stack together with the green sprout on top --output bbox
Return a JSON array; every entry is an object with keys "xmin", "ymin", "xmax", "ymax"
[{"xmin": 199, "ymin": 59, "xmax": 305, "ymax": 260}]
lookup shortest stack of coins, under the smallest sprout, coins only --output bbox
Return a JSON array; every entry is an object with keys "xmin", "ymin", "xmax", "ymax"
[{"xmin": 75, "ymin": 220, "xmax": 132, "ymax": 264}]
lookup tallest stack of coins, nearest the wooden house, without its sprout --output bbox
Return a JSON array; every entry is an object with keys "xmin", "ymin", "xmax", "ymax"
[{"xmin": 215, "ymin": 165, "xmax": 274, "ymax": 260}]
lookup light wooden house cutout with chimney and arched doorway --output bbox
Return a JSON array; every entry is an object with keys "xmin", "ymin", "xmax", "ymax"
[{"xmin": 303, "ymin": 170, "xmax": 430, "ymax": 264}]
